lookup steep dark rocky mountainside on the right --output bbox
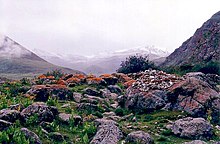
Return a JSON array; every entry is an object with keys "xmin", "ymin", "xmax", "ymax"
[{"xmin": 162, "ymin": 11, "xmax": 220, "ymax": 67}]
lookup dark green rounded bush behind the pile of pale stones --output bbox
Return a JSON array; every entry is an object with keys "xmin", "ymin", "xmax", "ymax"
[{"xmin": 117, "ymin": 54, "xmax": 155, "ymax": 74}]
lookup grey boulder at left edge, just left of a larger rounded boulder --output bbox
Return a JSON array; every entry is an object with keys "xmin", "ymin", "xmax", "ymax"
[{"xmin": 0, "ymin": 109, "xmax": 20, "ymax": 123}]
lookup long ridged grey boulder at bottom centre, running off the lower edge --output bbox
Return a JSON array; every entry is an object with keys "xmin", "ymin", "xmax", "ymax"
[{"xmin": 90, "ymin": 119, "xmax": 123, "ymax": 144}]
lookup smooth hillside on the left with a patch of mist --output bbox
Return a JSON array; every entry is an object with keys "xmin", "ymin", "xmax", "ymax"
[{"xmin": 0, "ymin": 35, "xmax": 80, "ymax": 77}]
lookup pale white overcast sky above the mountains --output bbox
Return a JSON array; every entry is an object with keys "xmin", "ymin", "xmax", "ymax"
[{"xmin": 0, "ymin": 0, "xmax": 220, "ymax": 55}]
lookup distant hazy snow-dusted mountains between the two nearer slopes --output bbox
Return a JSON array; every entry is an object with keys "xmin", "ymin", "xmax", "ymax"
[{"xmin": 33, "ymin": 46, "xmax": 169, "ymax": 75}]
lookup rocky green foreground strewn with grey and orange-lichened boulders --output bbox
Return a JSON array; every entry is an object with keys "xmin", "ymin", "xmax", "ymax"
[{"xmin": 0, "ymin": 70, "xmax": 220, "ymax": 144}]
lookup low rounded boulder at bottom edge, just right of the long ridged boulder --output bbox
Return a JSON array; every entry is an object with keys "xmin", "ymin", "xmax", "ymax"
[{"xmin": 125, "ymin": 131, "xmax": 154, "ymax": 144}]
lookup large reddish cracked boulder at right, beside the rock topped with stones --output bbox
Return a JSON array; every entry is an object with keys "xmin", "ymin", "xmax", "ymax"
[{"xmin": 168, "ymin": 77, "xmax": 220, "ymax": 121}]
